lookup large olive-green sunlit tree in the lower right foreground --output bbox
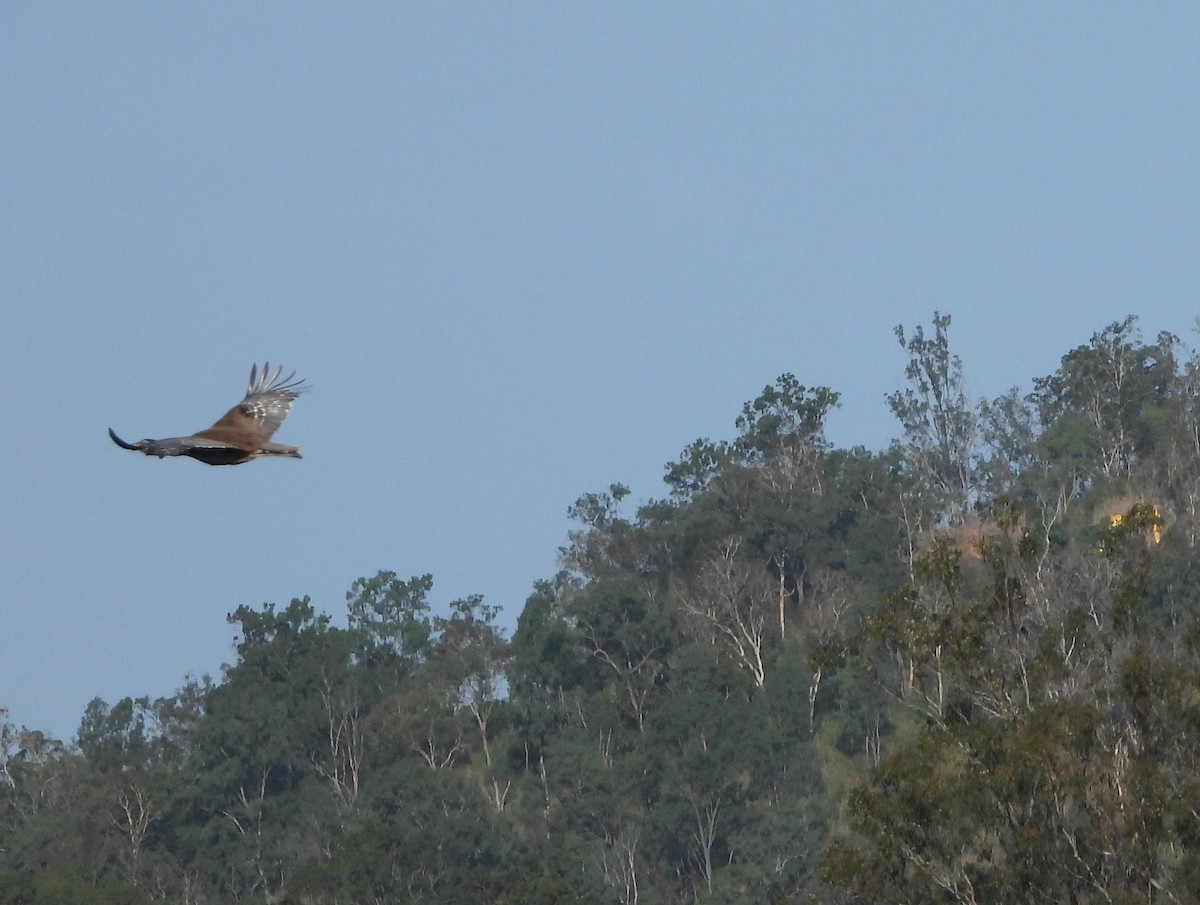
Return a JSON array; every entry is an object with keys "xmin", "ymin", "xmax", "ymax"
[{"xmin": 824, "ymin": 489, "xmax": 1200, "ymax": 903}]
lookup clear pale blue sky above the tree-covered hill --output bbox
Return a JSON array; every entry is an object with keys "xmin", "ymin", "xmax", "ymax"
[{"xmin": 0, "ymin": 0, "xmax": 1200, "ymax": 738}]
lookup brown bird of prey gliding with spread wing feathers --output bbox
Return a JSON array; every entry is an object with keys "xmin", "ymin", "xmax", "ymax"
[{"xmin": 108, "ymin": 364, "xmax": 308, "ymax": 465}]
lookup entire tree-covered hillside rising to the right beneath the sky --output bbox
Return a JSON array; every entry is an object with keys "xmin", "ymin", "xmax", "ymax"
[{"xmin": 0, "ymin": 314, "xmax": 1200, "ymax": 905}]
